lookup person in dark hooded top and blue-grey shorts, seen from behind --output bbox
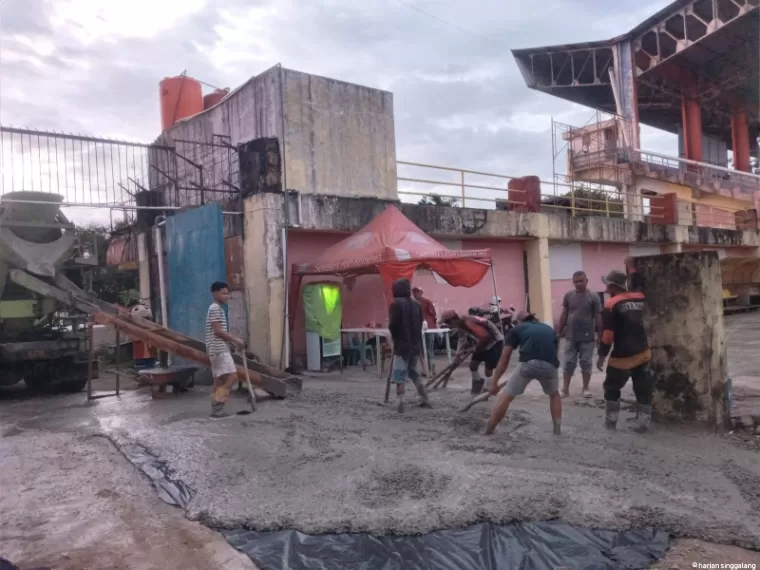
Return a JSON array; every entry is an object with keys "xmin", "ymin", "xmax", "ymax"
[{"xmin": 388, "ymin": 279, "xmax": 430, "ymax": 414}]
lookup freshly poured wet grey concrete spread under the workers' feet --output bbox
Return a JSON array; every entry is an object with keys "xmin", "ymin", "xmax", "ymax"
[{"xmin": 0, "ymin": 314, "xmax": 760, "ymax": 549}]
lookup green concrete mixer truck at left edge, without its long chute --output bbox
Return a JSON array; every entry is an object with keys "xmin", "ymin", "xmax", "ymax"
[{"xmin": 0, "ymin": 192, "xmax": 97, "ymax": 391}]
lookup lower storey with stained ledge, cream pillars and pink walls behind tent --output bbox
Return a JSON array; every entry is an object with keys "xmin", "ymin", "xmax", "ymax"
[{"xmin": 244, "ymin": 192, "xmax": 760, "ymax": 365}]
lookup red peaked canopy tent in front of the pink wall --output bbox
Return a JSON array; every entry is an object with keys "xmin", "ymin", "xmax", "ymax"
[{"xmin": 289, "ymin": 206, "xmax": 496, "ymax": 336}]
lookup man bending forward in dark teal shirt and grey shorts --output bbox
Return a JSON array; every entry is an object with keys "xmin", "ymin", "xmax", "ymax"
[{"xmin": 486, "ymin": 311, "xmax": 562, "ymax": 435}]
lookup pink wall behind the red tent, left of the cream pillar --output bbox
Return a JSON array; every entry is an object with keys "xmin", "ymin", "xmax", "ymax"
[{"xmin": 287, "ymin": 230, "xmax": 525, "ymax": 358}]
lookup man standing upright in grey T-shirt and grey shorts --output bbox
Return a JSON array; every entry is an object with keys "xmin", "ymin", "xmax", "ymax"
[{"xmin": 557, "ymin": 271, "xmax": 602, "ymax": 398}]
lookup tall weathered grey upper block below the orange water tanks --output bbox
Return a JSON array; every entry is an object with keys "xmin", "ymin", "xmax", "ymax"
[{"xmin": 156, "ymin": 67, "xmax": 397, "ymax": 205}]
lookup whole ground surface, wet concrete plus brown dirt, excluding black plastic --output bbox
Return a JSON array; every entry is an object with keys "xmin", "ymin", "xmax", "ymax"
[{"xmin": 0, "ymin": 314, "xmax": 760, "ymax": 569}]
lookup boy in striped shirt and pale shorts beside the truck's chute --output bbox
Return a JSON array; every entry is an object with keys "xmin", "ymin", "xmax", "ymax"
[{"xmin": 206, "ymin": 281, "xmax": 246, "ymax": 418}]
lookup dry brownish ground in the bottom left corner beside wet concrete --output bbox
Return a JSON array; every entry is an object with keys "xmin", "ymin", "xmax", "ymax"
[{"xmin": 0, "ymin": 428, "xmax": 256, "ymax": 570}]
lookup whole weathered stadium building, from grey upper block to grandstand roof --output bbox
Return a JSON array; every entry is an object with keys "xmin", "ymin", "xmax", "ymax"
[{"xmin": 150, "ymin": 13, "xmax": 760, "ymax": 367}]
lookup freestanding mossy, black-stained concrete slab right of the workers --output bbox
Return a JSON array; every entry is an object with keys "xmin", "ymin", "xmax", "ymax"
[{"xmin": 636, "ymin": 252, "xmax": 726, "ymax": 426}]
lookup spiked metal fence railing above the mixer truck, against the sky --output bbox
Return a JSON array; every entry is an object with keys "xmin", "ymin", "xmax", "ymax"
[{"xmin": 0, "ymin": 126, "xmax": 239, "ymax": 215}]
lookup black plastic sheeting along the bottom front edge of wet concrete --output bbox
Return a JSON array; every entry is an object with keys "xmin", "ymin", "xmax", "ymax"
[{"xmin": 223, "ymin": 522, "xmax": 669, "ymax": 570}]
